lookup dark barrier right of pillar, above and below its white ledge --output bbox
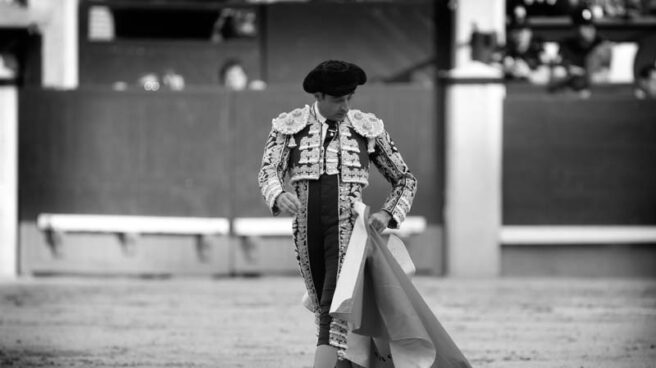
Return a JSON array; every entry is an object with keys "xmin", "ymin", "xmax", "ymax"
[{"xmin": 501, "ymin": 91, "xmax": 656, "ymax": 277}]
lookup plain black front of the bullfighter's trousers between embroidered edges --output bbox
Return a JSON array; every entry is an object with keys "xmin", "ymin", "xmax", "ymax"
[{"xmin": 307, "ymin": 175, "xmax": 339, "ymax": 346}]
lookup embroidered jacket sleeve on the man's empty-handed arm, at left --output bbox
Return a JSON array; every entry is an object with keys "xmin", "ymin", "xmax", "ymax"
[{"xmin": 258, "ymin": 130, "xmax": 287, "ymax": 216}]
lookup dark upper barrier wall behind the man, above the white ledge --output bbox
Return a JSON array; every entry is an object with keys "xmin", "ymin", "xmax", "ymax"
[{"xmin": 19, "ymin": 86, "xmax": 442, "ymax": 222}]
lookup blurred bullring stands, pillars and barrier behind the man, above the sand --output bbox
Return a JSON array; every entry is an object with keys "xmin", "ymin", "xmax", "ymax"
[{"xmin": 0, "ymin": 0, "xmax": 656, "ymax": 277}]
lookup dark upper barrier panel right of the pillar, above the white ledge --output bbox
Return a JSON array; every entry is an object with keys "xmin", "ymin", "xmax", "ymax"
[{"xmin": 503, "ymin": 94, "xmax": 656, "ymax": 225}]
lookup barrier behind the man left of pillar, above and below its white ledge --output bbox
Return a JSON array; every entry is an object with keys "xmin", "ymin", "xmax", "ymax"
[{"xmin": 19, "ymin": 86, "xmax": 443, "ymax": 274}]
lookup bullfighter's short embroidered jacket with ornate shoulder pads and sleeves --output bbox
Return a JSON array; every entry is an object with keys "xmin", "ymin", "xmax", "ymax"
[{"xmin": 258, "ymin": 105, "xmax": 417, "ymax": 228}]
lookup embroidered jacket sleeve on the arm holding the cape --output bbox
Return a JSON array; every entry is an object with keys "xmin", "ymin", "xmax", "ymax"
[{"xmin": 371, "ymin": 131, "xmax": 417, "ymax": 229}]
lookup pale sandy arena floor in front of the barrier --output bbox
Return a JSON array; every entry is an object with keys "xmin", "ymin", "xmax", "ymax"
[{"xmin": 0, "ymin": 277, "xmax": 656, "ymax": 368}]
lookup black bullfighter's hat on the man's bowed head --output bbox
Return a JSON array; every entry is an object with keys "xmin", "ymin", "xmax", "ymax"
[{"xmin": 303, "ymin": 60, "xmax": 367, "ymax": 96}]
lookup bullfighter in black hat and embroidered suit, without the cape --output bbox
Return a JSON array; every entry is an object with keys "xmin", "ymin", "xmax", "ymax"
[{"xmin": 258, "ymin": 60, "xmax": 417, "ymax": 368}]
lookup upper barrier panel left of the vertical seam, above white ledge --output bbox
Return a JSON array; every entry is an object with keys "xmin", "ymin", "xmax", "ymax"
[{"xmin": 19, "ymin": 89, "xmax": 231, "ymax": 221}]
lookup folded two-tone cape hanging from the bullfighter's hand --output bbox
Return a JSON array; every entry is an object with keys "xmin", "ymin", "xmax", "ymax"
[{"xmin": 330, "ymin": 203, "xmax": 471, "ymax": 368}]
